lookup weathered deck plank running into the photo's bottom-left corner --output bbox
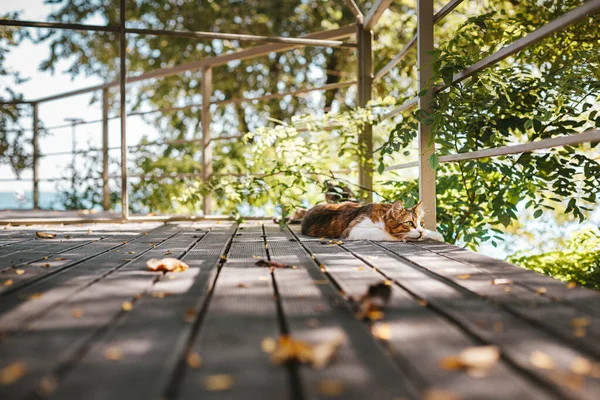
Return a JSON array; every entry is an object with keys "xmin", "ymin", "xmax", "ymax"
[{"xmin": 0, "ymin": 227, "xmax": 199, "ymax": 398}]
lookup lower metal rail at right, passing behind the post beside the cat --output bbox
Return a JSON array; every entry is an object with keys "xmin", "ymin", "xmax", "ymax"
[{"xmin": 385, "ymin": 129, "xmax": 600, "ymax": 171}]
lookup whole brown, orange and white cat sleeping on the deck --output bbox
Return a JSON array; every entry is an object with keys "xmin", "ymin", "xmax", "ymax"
[{"xmin": 302, "ymin": 201, "xmax": 444, "ymax": 242}]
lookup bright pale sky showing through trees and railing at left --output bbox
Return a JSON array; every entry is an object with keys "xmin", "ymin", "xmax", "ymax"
[{"xmin": 0, "ymin": 0, "xmax": 165, "ymax": 192}]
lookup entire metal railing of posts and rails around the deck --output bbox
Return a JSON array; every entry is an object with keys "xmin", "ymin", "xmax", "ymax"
[{"xmin": 0, "ymin": 0, "xmax": 600, "ymax": 229}]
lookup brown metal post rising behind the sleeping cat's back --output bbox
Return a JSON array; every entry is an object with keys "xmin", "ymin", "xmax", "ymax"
[{"xmin": 356, "ymin": 23, "xmax": 373, "ymax": 203}]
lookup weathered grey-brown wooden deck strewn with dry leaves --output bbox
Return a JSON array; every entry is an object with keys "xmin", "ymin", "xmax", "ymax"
[{"xmin": 0, "ymin": 222, "xmax": 600, "ymax": 400}]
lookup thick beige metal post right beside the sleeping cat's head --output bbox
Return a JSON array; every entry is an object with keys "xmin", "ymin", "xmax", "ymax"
[{"xmin": 417, "ymin": 0, "xmax": 436, "ymax": 230}]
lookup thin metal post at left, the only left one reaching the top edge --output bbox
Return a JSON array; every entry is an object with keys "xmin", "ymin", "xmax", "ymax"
[{"xmin": 119, "ymin": 0, "xmax": 129, "ymax": 221}]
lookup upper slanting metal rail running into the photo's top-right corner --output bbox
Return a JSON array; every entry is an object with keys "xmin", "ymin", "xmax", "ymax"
[{"xmin": 434, "ymin": 0, "xmax": 600, "ymax": 92}]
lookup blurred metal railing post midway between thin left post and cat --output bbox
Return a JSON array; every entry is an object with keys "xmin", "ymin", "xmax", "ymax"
[{"xmin": 200, "ymin": 67, "xmax": 212, "ymax": 215}]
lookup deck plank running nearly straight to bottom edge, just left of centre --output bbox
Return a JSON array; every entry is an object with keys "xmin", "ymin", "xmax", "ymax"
[{"xmin": 177, "ymin": 224, "xmax": 291, "ymax": 399}]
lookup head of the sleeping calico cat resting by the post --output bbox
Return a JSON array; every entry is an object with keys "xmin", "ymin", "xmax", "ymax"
[{"xmin": 383, "ymin": 201, "xmax": 425, "ymax": 240}]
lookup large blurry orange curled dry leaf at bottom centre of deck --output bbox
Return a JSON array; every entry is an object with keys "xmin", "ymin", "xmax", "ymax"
[{"xmin": 261, "ymin": 332, "xmax": 344, "ymax": 369}]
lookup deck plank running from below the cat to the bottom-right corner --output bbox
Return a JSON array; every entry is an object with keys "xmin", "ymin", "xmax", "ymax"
[{"xmin": 366, "ymin": 242, "xmax": 600, "ymax": 399}]
